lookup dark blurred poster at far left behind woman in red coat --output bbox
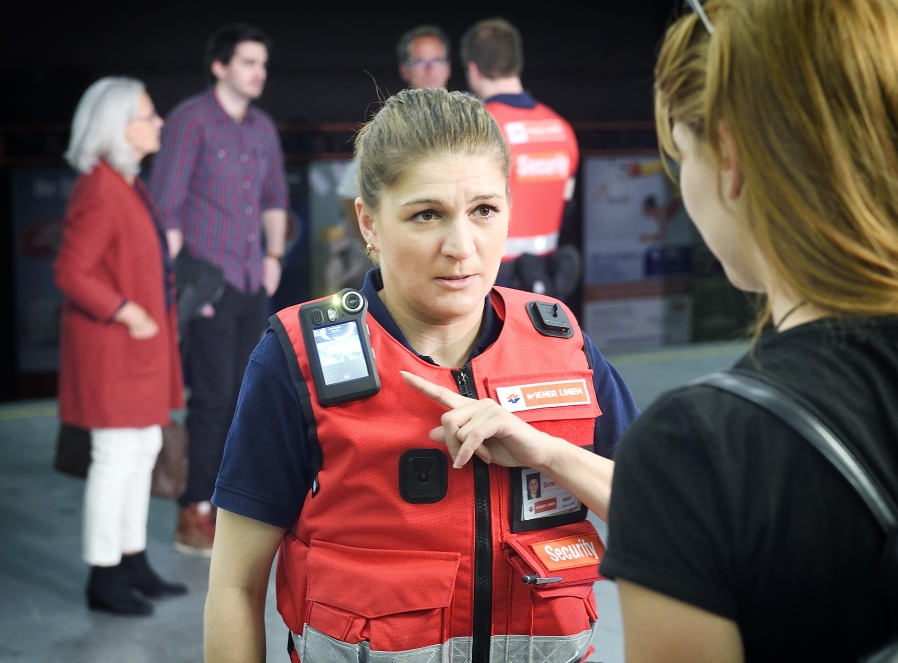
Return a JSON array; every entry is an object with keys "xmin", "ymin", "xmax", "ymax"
[{"xmin": 12, "ymin": 166, "xmax": 75, "ymax": 374}]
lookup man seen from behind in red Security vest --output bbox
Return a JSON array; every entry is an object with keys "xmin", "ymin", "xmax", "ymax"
[{"xmin": 461, "ymin": 18, "xmax": 580, "ymax": 299}]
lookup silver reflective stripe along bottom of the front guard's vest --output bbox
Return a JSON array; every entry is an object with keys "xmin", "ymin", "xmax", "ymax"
[{"xmin": 292, "ymin": 624, "xmax": 595, "ymax": 663}]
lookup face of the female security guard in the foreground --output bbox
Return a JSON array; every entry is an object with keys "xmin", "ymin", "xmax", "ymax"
[{"xmin": 359, "ymin": 156, "xmax": 509, "ymax": 332}]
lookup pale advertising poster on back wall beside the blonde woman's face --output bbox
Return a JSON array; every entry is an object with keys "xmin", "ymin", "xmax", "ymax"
[{"xmin": 581, "ymin": 157, "xmax": 697, "ymax": 350}]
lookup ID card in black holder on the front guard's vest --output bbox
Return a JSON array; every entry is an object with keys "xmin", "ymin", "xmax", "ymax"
[{"xmin": 510, "ymin": 467, "xmax": 587, "ymax": 532}]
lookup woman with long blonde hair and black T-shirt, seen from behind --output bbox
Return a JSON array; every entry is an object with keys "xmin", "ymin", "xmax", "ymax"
[{"xmin": 424, "ymin": 0, "xmax": 898, "ymax": 663}]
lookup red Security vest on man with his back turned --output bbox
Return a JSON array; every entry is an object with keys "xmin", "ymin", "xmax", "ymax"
[{"xmin": 486, "ymin": 101, "xmax": 580, "ymax": 260}]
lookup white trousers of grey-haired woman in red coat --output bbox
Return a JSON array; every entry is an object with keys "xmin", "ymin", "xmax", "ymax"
[{"xmin": 83, "ymin": 426, "xmax": 162, "ymax": 566}]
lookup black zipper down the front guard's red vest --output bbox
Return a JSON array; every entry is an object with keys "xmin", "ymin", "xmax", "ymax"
[{"xmin": 452, "ymin": 362, "xmax": 493, "ymax": 663}]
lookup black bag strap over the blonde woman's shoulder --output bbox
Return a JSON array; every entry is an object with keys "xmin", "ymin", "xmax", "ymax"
[{"xmin": 690, "ymin": 369, "xmax": 898, "ymax": 663}]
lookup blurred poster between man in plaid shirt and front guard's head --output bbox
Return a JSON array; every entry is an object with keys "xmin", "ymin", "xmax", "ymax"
[{"xmin": 309, "ymin": 160, "xmax": 370, "ymax": 297}]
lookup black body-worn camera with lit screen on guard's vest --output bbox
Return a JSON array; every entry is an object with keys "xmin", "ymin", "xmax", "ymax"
[{"xmin": 299, "ymin": 288, "xmax": 380, "ymax": 405}]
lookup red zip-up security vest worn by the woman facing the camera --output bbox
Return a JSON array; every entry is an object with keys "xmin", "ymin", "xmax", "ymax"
[{"xmin": 276, "ymin": 288, "xmax": 603, "ymax": 663}]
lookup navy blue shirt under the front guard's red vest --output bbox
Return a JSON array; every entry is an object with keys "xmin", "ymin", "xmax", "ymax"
[{"xmin": 212, "ymin": 269, "xmax": 639, "ymax": 528}]
